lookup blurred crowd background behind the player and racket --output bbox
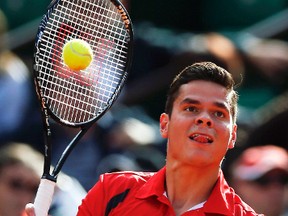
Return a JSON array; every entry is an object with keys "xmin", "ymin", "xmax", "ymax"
[{"xmin": 0, "ymin": 0, "xmax": 288, "ymax": 216}]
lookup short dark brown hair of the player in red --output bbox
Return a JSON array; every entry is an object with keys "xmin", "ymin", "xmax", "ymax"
[{"xmin": 165, "ymin": 62, "xmax": 238, "ymax": 122}]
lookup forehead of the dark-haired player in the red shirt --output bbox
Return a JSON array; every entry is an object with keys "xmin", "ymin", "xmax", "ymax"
[{"xmin": 177, "ymin": 80, "xmax": 231, "ymax": 103}]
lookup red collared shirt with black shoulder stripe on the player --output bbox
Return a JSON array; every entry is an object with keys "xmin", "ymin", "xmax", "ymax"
[{"xmin": 77, "ymin": 167, "xmax": 259, "ymax": 216}]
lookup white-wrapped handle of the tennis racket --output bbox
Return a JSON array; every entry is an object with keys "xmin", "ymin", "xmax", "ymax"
[{"xmin": 34, "ymin": 179, "xmax": 56, "ymax": 216}]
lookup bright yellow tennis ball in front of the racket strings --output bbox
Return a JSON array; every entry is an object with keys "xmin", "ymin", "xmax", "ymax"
[{"xmin": 62, "ymin": 39, "xmax": 93, "ymax": 71}]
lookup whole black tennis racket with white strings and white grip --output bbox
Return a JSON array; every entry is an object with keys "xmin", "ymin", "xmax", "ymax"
[{"xmin": 34, "ymin": 0, "xmax": 133, "ymax": 216}]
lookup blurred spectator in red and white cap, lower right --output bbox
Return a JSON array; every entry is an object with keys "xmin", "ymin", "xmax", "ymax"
[{"xmin": 229, "ymin": 145, "xmax": 288, "ymax": 216}]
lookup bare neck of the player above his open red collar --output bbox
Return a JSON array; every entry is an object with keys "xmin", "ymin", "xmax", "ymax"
[{"xmin": 166, "ymin": 164, "xmax": 219, "ymax": 215}]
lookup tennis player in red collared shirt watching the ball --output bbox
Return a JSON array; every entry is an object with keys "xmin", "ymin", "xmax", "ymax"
[{"xmin": 27, "ymin": 62, "xmax": 260, "ymax": 216}]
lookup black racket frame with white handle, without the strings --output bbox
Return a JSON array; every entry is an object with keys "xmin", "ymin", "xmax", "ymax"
[{"xmin": 33, "ymin": 0, "xmax": 133, "ymax": 216}]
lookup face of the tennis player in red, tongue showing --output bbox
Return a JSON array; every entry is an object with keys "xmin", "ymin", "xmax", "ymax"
[{"xmin": 160, "ymin": 80, "xmax": 237, "ymax": 167}]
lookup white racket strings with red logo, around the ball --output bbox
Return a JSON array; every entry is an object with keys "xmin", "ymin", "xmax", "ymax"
[{"xmin": 37, "ymin": 0, "xmax": 129, "ymax": 124}]
